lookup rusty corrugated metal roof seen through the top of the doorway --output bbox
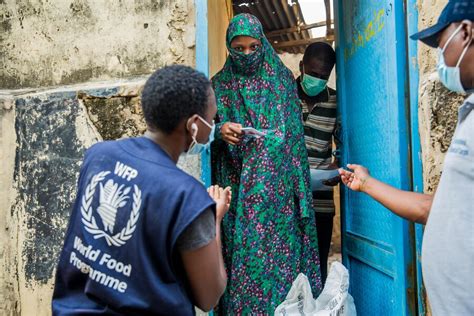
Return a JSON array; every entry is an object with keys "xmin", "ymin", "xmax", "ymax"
[{"xmin": 232, "ymin": 0, "xmax": 311, "ymax": 53}]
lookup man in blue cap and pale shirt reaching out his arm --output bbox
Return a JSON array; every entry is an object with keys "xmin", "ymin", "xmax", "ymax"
[{"xmin": 339, "ymin": 0, "xmax": 474, "ymax": 315}]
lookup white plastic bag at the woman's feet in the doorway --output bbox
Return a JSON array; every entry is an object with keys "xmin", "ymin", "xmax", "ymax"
[{"xmin": 275, "ymin": 261, "xmax": 357, "ymax": 316}]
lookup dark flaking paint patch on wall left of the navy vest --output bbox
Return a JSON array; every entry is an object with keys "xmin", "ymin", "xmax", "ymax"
[{"xmin": 14, "ymin": 92, "xmax": 85, "ymax": 286}]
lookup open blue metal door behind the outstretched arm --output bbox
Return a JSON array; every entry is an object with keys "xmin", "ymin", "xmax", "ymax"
[{"xmin": 335, "ymin": 0, "xmax": 416, "ymax": 316}]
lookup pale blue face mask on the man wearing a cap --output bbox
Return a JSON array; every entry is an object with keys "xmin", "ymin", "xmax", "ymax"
[{"xmin": 437, "ymin": 25, "xmax": 472, "ymax": 93}]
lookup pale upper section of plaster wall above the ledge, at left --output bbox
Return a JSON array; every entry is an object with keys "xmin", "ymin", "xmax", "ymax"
[{"xmin": 0, "ymin": 0, "xmax": 195, "ymax": 89}]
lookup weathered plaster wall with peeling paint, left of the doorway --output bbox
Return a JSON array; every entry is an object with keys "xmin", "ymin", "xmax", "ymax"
[{"xmin": 0, "ymin": 0, "xmax": 200, "ymax": 315}]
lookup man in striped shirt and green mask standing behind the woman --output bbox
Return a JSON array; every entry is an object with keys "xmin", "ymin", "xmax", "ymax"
[{"xmin": 296, "ymin": 42, "xmax": 339, "ymax": 282}]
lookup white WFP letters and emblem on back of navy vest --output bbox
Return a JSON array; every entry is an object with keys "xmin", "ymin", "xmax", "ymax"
[{"xmin": 81, "ymin": 161, "xmax": 142, "ymax": 247}]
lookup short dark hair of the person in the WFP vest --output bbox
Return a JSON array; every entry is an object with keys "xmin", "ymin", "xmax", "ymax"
[{"xmin": 141, "ymin": 65, "xmax": 211, "ymax": 134}]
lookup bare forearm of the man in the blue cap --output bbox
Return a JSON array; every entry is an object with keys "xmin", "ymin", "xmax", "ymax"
[{"xmin": 361, "ymin": 177, "xmax": 433, "ymax": 224}]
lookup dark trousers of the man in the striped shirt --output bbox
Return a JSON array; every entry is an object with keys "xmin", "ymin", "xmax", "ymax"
[{"xmin": 316, "ymin": 213, "xmax": 334, "ymax": 285}]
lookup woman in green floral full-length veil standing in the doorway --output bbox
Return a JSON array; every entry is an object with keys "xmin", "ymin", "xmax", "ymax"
[{"xmin": 212, "ymin": 14, "xmax": 321, "ymax": 315}]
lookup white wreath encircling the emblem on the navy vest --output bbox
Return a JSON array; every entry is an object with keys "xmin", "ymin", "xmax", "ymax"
[{"xmin": 81, "ymin": 171, "xmax": 142, "ymax": 247}]
